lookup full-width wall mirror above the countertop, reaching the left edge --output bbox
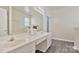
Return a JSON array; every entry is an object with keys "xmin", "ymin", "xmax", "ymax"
[{"xmin": 0, "ymin": 6, "xmax": 43, "ymax": 36}]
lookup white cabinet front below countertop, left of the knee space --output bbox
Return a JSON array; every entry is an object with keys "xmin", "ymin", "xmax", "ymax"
[{"xmin": 9, "ymin": 42, "xmax": 35, "ymax": 53}]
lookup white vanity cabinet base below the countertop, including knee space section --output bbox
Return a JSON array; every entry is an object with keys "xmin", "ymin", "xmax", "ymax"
[{"xmin": 9, "ymin": 33, "xmax": 52, "ymax": 53}]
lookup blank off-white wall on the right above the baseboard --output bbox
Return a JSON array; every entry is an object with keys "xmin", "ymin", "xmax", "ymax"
[{"xmin": 52, "ymin": 7, "xmax": 79, "ymax": 41}]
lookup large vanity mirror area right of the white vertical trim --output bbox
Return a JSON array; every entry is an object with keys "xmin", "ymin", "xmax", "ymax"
[{"xmin": 12, "ymin": 6, "xmax": 43, "ymax": 34}]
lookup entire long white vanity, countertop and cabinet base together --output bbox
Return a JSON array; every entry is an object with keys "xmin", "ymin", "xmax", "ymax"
[{"xmin": 0, "ymin": 32, "xmax": 51, "ymax": 53}]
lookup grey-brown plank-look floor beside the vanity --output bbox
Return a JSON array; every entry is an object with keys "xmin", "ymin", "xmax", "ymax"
[{"xmin": 36, "ymin": 39, "xmax": 79, "ymax": 53}]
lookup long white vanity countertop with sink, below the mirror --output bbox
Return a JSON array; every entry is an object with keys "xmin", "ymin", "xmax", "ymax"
[{"xmin": 0, "ymin": 32, "xmax": 50, "ymax": 53}]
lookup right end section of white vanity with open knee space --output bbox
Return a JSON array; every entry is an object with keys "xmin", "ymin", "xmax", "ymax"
[{"xmin": 36, "ymin": 34, "xmax": 52, "ymax": 52}]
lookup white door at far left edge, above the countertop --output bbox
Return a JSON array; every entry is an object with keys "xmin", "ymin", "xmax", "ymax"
[{"xmin": 0, "ymin": 8, "xmax": 7, "ymax": 36}]
